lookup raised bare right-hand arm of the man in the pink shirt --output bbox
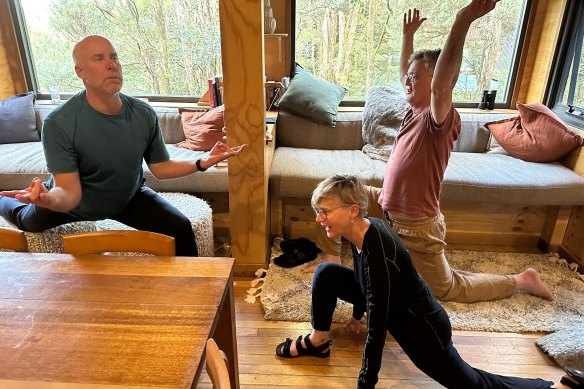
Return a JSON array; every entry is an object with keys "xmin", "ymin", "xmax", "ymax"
[{"xmin": 430, "ymin": 0, "xmax": 499, "ymax": 125}]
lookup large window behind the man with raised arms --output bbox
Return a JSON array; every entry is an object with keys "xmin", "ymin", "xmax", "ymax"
[{"xmin": 294, "ymin": 0, "xmax": 531, "ymax": 107}]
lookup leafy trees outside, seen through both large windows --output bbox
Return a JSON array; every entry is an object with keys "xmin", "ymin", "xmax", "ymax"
[{"xmin": 21, "ymin": 0, "xmax": 532, "ymax": 101}]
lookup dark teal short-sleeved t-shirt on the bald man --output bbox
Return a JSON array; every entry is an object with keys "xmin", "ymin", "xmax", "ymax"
[{"xmin": 42, "ymin": 91, "xmax": 170, "ymax": 220}]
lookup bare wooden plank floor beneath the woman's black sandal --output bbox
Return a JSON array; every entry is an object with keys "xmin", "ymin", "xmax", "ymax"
[{"xmin": 197, "ymin": 272, "xmax": 563, "ymax": 389}]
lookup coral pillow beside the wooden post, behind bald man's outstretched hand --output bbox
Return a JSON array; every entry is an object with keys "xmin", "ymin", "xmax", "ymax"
[{"xmin": 175, "ymin": 105, "xmax": 225, "ymax": 151}]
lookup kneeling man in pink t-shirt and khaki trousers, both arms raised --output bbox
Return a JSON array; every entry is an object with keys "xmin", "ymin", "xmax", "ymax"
[{"xmin": 306, "ymin": 0, "xmax": 553, "ymax": 302}]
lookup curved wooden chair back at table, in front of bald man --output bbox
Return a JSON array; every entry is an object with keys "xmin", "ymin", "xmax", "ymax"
[{"xmin": 63, "ymin": 230, "xmax": 175, "ymax": 256}]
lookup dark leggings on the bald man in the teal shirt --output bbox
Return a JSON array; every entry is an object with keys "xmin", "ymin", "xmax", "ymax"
[{"xmin": 0, "ymin": 185, "xmax": 199, "ymax": 257}]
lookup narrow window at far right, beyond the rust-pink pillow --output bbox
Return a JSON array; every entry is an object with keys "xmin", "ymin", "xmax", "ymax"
[{"xmin": 546, "ymin": 0, "xmax": 584, "ymax": 129}]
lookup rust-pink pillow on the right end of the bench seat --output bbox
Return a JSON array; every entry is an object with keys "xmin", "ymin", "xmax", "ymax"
[{"xmin": 485, "ymin": 103, "xmax": 584, "ymax": 162}]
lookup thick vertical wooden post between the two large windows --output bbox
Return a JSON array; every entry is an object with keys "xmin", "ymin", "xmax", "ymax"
[{"xmin": 219, "ymin": 0, "xmax": 269, "ymax": 273}]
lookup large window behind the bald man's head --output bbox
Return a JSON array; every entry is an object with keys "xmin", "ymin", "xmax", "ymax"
[{"xmin": 12, "ymin": 0, "xmax": 221, "ymax": 100}]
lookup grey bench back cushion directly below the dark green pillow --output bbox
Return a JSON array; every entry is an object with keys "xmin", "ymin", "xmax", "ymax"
[{"xmin": 276, "ymin": 111, "xmax": 363, "ymax": 150}]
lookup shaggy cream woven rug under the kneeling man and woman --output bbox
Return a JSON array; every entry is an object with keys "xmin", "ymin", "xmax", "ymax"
[{"xmin": 246, "ymin": 239, "xmax": 584, "ymax": 332}]
